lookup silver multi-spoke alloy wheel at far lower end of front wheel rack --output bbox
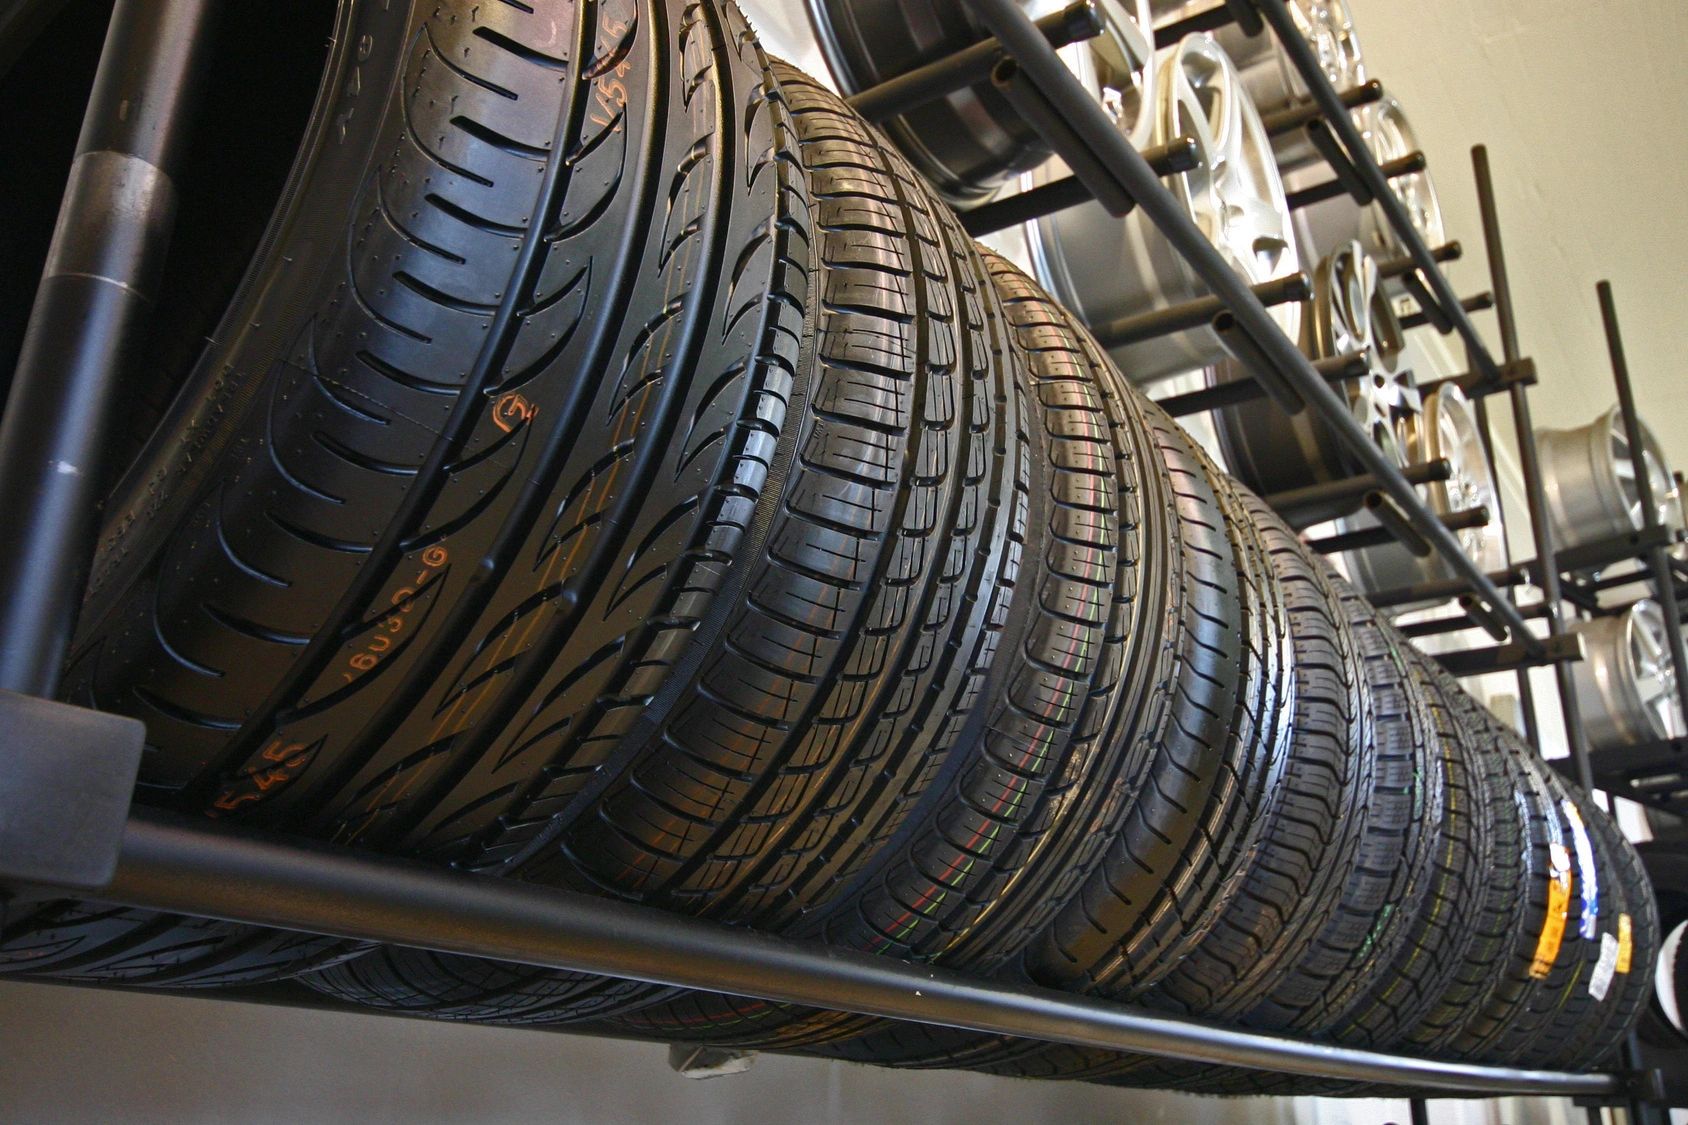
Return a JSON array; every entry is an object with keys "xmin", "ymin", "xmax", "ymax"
[{"xmin": 1344, "ymin": 383, "xmax": 1506, "ymax": 594}]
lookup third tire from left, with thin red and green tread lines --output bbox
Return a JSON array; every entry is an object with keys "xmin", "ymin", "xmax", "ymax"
[{"xmin": 600, "ymin": 236, "xmax": 1143, "ymax": 1047}]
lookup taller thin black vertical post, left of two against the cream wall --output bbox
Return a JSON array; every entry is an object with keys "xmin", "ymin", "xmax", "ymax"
[{"xmin": 1472, "ymin": 145, "xmax": 1593, "ymax": 792}]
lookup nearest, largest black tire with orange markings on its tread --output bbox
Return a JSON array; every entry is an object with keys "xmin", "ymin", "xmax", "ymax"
[{"xmin": 0, "ymin": 0, "xmax": 807, "ymax": 983}]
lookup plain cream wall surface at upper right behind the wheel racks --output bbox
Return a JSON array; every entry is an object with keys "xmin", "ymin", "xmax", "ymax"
[{"xmin": 1349, "ymin": 0, "xmax": 1688, "ymax": 470}]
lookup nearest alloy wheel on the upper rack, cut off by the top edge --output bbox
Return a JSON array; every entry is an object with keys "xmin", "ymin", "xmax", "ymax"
[{"xmin": 807, "ymin": 0, "xmax": 1155, "ymax": 208}]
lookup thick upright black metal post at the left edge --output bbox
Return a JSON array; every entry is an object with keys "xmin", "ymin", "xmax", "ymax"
[{"xmin": 0, "ymin": 0, "xmax": 218, "ymax": 696}]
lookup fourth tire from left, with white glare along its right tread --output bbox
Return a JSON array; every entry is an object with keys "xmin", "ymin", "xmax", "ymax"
[{"xmin": 822, "ymin": 363, "xmax": 1291, "ymax": 1074}]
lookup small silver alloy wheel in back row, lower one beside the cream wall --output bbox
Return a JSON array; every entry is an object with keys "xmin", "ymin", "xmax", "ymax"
[{"xmin": 1290, "ymin": 95, "xmax": 1447, "ymax": 258}]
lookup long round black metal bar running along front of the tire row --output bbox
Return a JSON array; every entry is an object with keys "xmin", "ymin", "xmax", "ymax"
[{"xmin": 59, "ymin": 811, "xmax": 1615, "ymax": 1095}]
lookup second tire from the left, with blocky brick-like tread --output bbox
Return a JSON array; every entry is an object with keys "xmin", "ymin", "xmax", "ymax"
[{"xmin": 316, "ymin": 48, "xmax": 1038, "ymax": 1013}]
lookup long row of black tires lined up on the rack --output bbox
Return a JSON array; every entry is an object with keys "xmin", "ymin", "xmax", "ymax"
[{"xmin": 0, "ymin": 0, "xmax": 1658, "ymax": 1093}]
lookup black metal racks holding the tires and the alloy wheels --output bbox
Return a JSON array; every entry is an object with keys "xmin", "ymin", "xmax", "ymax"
[{"xmin": 0, "ymin": 0, "xmax": 1688, "ymax": 1111}]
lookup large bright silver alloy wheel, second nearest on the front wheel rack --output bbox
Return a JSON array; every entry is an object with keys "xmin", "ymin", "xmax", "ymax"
[{"xmin": 1026, "ymin": 35, "xmax": 1301, "ymax": 383}]
